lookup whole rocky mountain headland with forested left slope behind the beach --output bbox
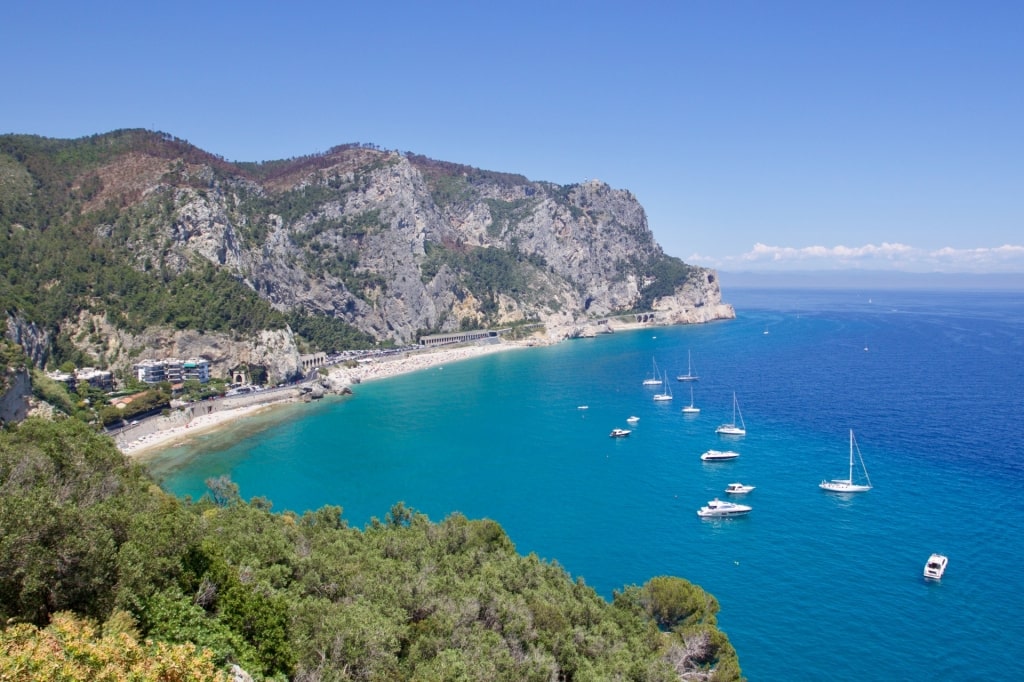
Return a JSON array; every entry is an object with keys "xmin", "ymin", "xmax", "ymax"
[{"xmin": 0, "ymin": 130, "xmax": 733, "ymax": 382}]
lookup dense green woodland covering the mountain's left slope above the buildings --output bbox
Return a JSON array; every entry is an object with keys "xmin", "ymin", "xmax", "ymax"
[{"xmin": 0, "ymin": 131, "xmax": 296, "ymax": 364}]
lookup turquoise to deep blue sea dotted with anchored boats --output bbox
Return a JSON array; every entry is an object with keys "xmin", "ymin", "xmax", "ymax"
[{"xmin": 144, "ymin": 290, "xmax": 1024, "ymax": 680}]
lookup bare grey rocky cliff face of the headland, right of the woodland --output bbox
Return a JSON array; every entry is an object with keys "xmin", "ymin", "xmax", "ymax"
[{"xmin": 0, "ymin": 131, "xmax": 733, "ymax": 378}]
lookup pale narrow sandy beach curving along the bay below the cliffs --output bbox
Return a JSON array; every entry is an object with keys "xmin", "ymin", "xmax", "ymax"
[{"xmin": 116, "ymin": 342, "xmax": 526, "ymax": 458}]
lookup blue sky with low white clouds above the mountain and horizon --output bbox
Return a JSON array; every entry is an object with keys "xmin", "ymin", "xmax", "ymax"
[{"xmin": 0, "ymin": 0, "xmax": 1024, "ymax": 272}]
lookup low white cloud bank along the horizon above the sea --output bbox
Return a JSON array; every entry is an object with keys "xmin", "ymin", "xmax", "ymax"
[{"xmin": 688, "ymin": 242, "xmax": 1024, "ymax": 272}]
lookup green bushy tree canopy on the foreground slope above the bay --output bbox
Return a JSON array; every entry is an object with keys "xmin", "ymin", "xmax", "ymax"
[{"xmin": 0, "ymin": 420, "xmax": 740, "ymax": 681}]
